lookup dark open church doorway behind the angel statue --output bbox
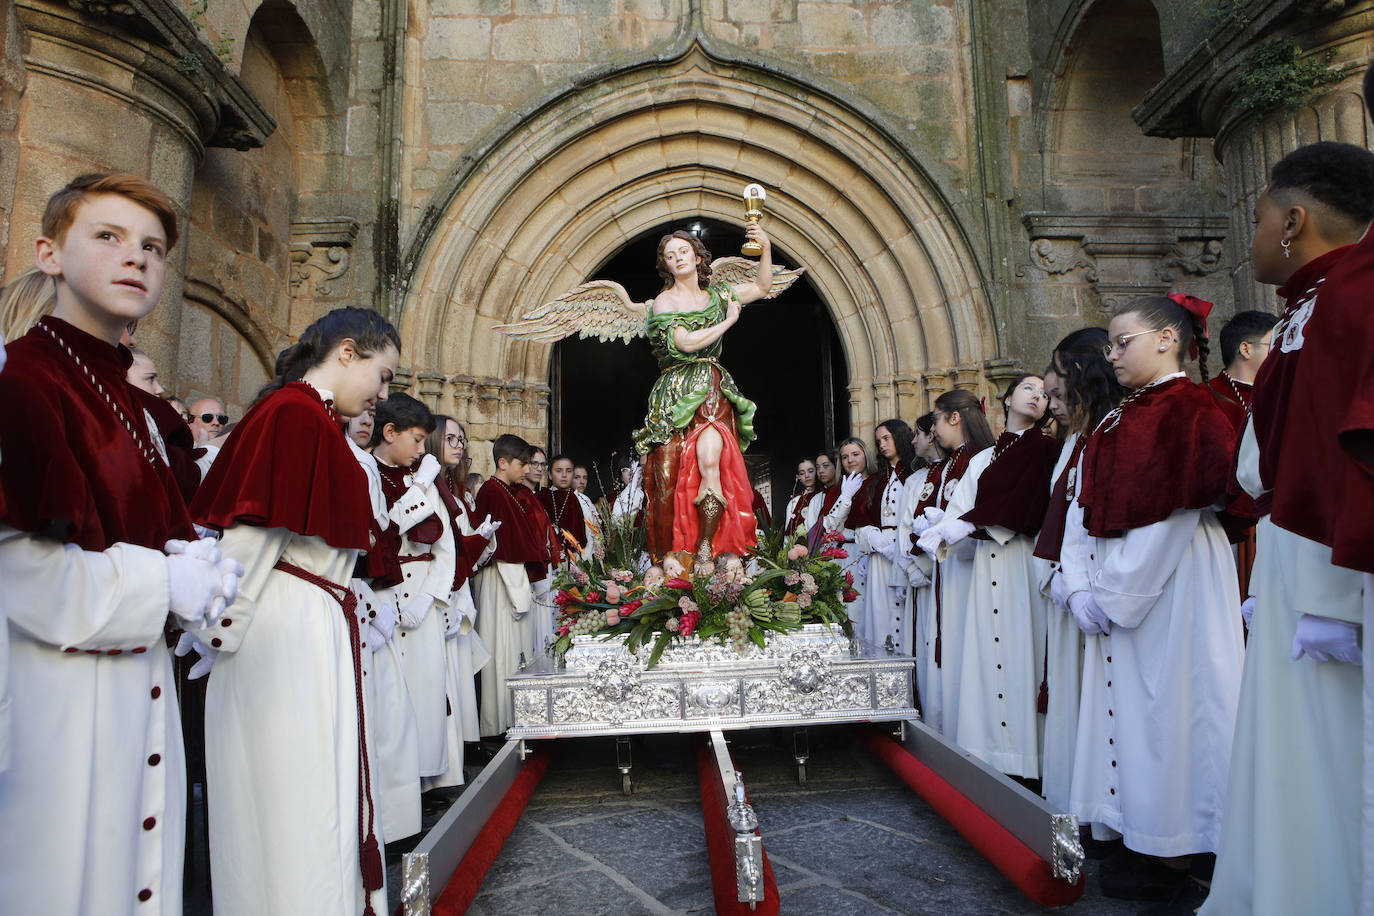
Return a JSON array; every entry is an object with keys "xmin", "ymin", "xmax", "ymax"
[{"xmin": 550, "ymin": 220, "xmax": 849, "ymax": 519}]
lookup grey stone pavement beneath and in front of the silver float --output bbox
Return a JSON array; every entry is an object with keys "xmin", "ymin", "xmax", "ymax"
[{"xmin": 469, "ymin": 728, "xmax": 1142, "ymax": 916}]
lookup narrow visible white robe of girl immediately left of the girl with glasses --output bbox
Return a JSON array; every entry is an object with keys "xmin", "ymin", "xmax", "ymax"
[{"xmin": 1033, "ymin": 433, "xmax": 1087, "ymax": 812}]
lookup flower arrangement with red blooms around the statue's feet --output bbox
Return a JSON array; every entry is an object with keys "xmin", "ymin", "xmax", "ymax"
[{"xmin": 554, "ymin": 523, "xmax": 856, "ymax": 667}]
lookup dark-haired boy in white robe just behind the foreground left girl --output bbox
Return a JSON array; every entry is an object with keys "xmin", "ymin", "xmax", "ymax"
[{"xmin": 368, "ymin": 394, "xmax": 458, "ymax": 842}]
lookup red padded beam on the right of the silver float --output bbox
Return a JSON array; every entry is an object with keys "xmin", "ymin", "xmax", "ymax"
[{"xmin": 853, "ymin": 728, "xmax": 1085, "ymax": 906}]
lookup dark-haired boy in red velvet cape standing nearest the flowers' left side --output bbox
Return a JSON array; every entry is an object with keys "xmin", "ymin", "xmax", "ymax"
[{"xmin": 474, "ymin": 433, "xmax": 552, "ymax": 737}]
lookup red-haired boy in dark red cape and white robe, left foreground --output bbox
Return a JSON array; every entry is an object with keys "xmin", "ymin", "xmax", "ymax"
[{"xmin": 0, "ymin": 174, "xmax": 243, "ymax": 913}]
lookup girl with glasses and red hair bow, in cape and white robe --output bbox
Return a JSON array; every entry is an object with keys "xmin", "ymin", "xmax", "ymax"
[{"xmin": 1061, "ymin": 295, "xmax": 1243, "ymax": 900}]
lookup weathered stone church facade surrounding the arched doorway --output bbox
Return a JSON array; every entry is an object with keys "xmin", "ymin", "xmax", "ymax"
[{"xmin": 0, "ymin": 0, "xmax": 1374, "ymax": 470}]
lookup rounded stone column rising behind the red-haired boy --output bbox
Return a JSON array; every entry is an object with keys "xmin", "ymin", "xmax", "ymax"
[{"xmin": 5, "ymin": 0, "xmax": 276, "ymax": 376}]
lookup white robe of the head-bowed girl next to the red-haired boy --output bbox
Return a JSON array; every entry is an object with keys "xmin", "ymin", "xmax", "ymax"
[{"xmin": 205, "ymin": 525, "xmax": 386, "ymax": 916}]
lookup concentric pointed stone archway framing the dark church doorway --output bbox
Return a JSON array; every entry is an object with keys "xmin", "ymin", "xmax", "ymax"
[{"xmin": 396, "ymin": 45, "xmax": 999, "ymax": 469}]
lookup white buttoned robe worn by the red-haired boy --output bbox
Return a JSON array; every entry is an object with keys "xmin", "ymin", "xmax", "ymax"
[{"xmin": 0, "ymin": 527, "xmax": 185, "ymax": 916}]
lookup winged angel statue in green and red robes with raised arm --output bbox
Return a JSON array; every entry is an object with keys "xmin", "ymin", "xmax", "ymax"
[{"xmin": 496, "ymin": 222, "xmax": 802, "ymax": 563}]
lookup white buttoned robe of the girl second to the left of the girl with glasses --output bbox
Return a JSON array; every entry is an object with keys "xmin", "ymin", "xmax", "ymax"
[{"xmin": 945, "ymin": 448, "xmax": 1046, "ymax": 779}]
